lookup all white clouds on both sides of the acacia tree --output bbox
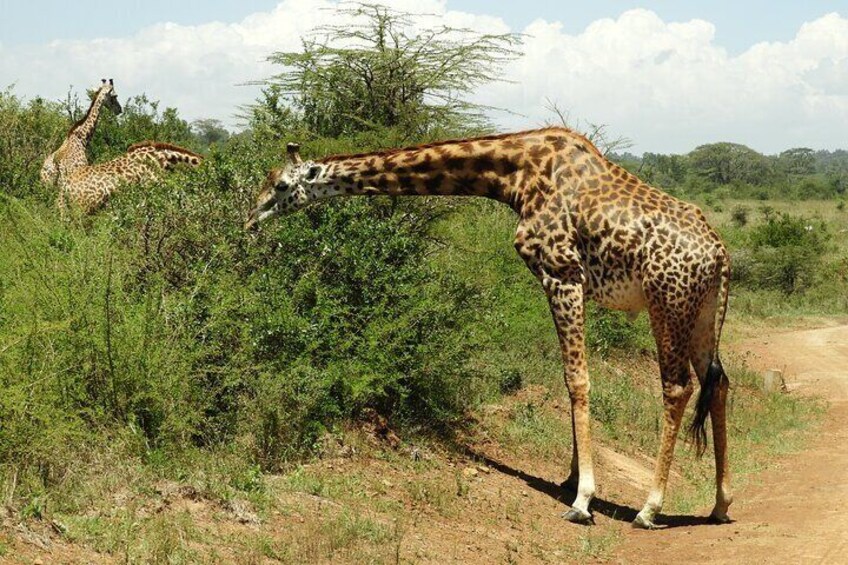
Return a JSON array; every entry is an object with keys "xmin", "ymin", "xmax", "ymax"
[{"xmin": 0, "ymin": 0, "xmax": 848, "ymax": 152}]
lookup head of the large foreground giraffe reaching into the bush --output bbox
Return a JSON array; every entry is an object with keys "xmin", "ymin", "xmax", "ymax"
[{"xmin": 245, "ymin": 143, "xmax": 325, "ymax": 229}]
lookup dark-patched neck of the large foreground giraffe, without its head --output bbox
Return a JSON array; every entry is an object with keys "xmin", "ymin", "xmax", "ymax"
[{"xmin": 314, "ymin": 139, "xmax": 522, "ymax": 206}]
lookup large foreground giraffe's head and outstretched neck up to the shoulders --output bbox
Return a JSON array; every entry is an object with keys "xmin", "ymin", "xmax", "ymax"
[{"xmin": 247, "ymin": 128, "xmax": 608, "ymax": 227}]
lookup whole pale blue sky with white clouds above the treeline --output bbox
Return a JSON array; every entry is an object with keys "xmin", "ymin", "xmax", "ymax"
[{"xmin": 0, "ymin": 0, "xmax": 848, "ymax": 152}]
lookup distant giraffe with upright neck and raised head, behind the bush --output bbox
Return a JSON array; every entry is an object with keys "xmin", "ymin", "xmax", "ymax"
[{"xmin": 41, "ymin": 78, "xmax": 123, "ymax": 185}]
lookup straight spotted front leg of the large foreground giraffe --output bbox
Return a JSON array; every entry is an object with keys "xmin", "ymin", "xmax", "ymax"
[{"xmin": 542, "ymin": 271, "xmax": 595, "ymax": 524}]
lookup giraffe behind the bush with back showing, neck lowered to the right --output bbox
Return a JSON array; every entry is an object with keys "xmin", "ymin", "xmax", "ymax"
[{"xmin": 59, "ymin": 141, "xmax": 203, "ymax": 214}]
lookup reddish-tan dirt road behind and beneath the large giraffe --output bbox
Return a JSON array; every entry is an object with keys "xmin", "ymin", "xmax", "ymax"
[{"xmin": 616, "ymin": 326, "xmax": 848, "ymax": 564}]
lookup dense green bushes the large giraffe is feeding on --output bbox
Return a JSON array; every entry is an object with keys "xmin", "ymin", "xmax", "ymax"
[{"xmin": 0, "ymin": 125, "xmax": 494, "ymax": 486}]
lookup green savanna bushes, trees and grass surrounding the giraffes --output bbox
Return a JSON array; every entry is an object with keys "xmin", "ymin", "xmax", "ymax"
[{"xmin": 0, "ymin": 5, "xmax": 848, "ymax": 562}]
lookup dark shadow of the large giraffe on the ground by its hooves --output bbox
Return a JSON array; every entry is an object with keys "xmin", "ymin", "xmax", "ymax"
[{"xmin": 465, "ymin": 447, "xmax": 712, "ymax": 529}]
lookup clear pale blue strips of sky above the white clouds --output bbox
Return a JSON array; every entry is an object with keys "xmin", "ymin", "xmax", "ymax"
[{"xmin": 0, "ymin": 0, "xmax": 848, "ymax": 53}]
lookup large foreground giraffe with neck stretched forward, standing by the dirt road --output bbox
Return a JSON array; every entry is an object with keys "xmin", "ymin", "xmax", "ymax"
[{"xmin": 245, "ymin": 128, "xmax": 732, "ymax": 529}]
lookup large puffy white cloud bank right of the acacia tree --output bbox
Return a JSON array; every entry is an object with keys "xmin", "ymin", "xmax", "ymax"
[{"xmin": 483, "ymin": 10, "xmax": 848, "ymax": 152}]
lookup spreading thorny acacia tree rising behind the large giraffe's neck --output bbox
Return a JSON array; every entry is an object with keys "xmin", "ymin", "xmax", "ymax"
[{"xmin": 263, "ymin": 3, "xmax": 520, "ymax": 139}]
